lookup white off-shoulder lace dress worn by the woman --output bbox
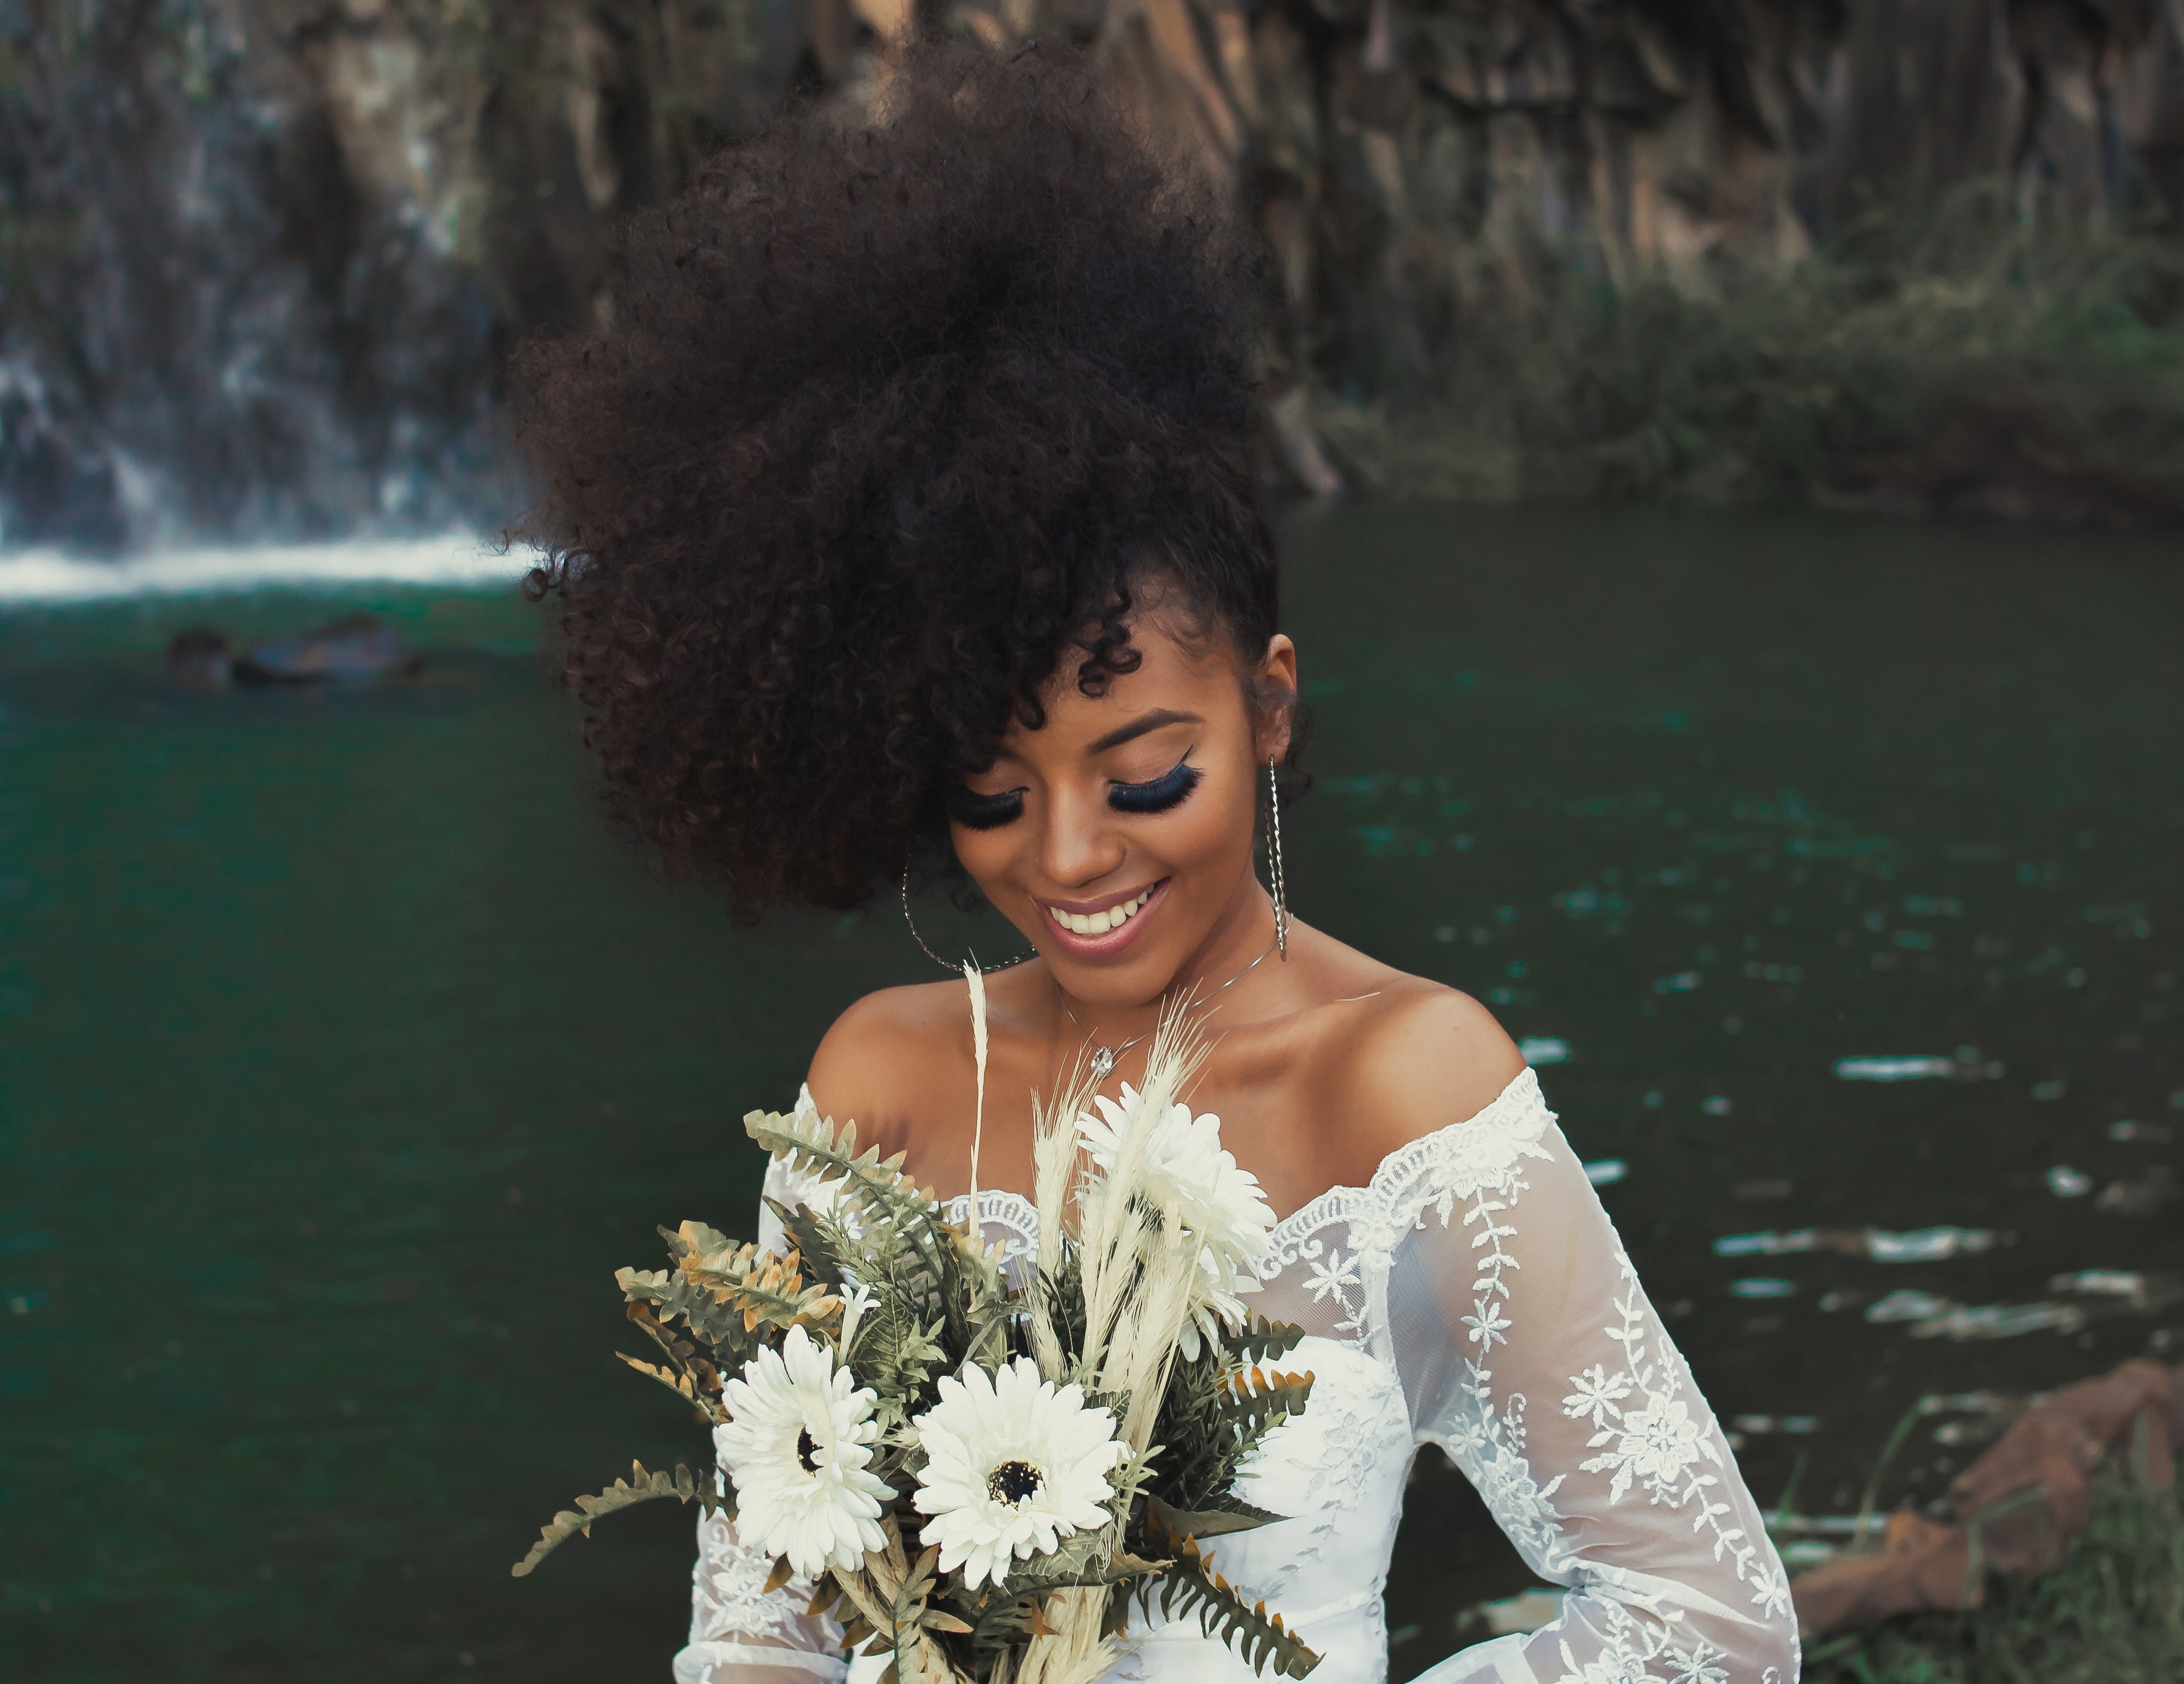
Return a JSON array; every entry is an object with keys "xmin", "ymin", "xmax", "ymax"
[{"xmin": 675, "ymin": 1070, "xmax": 1797, "ymax": 1684}]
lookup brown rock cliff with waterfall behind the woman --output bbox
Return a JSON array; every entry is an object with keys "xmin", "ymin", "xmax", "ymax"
[{"xmin": 0, "ymin": 0, "xmax": 2184, "ymax": 550}]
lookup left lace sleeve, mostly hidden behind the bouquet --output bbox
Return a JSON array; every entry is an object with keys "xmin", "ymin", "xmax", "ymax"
[{"xmin": 675, "ymin": 1162, "xmax": 849, "ymax": 1684}]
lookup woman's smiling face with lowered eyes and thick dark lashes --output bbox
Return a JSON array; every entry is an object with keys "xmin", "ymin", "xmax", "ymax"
[{"xmin": 950, "ymin": 607, "xmax": 1297, "ymax": 1005}]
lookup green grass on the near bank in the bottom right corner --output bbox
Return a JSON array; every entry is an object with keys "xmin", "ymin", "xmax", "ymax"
[{"xmin": 1804, "ymin": 1475, "xmax": 2184, "ymax": 1684}]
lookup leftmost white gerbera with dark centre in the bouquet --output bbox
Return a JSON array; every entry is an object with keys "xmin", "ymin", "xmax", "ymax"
[{"xmin": 712, "ymin": 1328, "xmax": 895, "ymax": 1577}]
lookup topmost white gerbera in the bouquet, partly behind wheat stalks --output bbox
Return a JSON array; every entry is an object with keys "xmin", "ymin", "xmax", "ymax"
[{"xmin": 1077, "ymin": 1081, "xmax": 1273, "ymax": 1358}]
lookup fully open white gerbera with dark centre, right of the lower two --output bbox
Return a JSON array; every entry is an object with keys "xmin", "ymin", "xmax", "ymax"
[{"xmin": 911, "ymin": 1357, "xmax": 1122, "ymax": 1586}]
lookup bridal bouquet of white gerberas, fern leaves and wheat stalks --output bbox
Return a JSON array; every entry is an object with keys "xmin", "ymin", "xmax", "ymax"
[{"xmin": 516, "ymin": 987, "xmax": 1319, "ymax": 1684}]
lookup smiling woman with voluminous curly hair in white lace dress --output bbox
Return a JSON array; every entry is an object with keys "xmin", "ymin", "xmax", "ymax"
[{"xmin": 522, "ymin": 48, "xmax": 1797, "ymax": 1684}]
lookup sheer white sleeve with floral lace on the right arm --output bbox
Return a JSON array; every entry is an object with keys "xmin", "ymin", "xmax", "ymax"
[{"xmin": 1363, "ymin": 1072, "xmax": 1800, "ymax": 1684}]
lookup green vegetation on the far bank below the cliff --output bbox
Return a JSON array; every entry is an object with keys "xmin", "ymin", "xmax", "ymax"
[{"xmin": 1321, "ymin": 183, "xmax": 2184, "ymax": 524}]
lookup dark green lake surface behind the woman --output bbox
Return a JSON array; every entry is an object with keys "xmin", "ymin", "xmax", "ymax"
[{"xmin": 0, "ymin": 509, "xmax": 2184, "ymax": 1684}]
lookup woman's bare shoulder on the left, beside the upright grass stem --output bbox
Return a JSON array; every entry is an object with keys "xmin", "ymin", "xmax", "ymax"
[{"xmin": 808, "ymin": 983, "xmax": 970, "ymax": 1149}]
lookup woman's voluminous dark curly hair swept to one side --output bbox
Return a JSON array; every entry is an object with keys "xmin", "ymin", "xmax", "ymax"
[{"xmin": 516, "ymin": 41, "xmax": 1278, "ymax": 915}]
